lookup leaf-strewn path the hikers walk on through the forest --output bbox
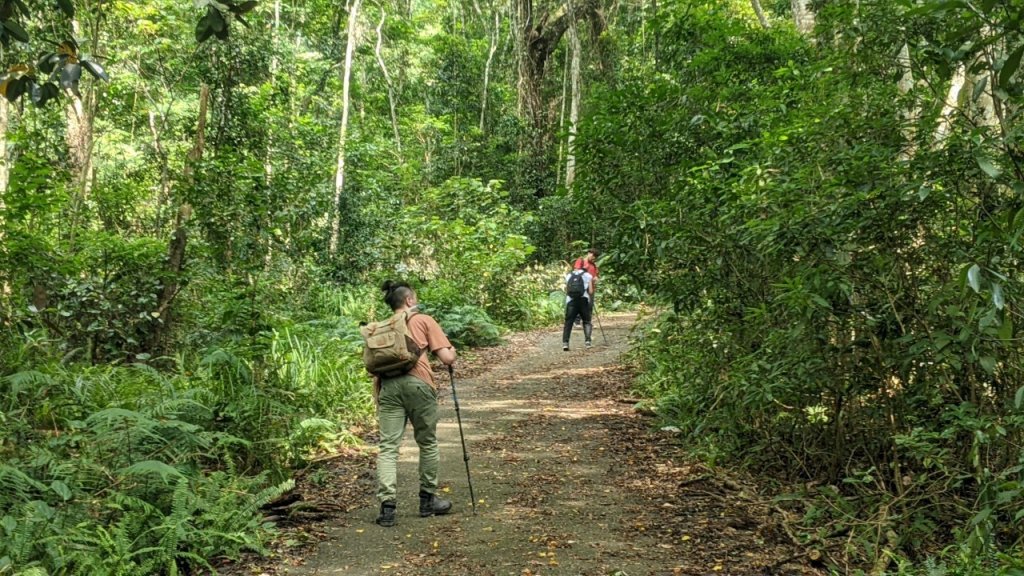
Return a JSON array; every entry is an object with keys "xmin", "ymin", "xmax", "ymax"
[{"xmin": 214, "ymin": 314, "xmax": 826, "ymax": 576}]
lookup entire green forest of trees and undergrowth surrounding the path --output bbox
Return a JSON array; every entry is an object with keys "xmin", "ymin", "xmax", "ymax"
[{"xmin": 0, "ymin": 0, "xmax": 1024, "ymax": 576}]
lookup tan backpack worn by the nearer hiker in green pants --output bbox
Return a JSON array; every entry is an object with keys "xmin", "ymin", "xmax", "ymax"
[{"xmin": 359, "ymin": 311, "xmax": 424, "ymax": 377}]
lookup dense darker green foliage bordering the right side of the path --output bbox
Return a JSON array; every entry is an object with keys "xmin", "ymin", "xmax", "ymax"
[{"xmin": 570, "ymin": 2, "xmax": 1024, "ymax": 574}]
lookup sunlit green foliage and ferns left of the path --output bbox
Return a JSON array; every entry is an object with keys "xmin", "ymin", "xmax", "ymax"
[{"xmin": 0, "ymin": 0, "xmax": 561, "ymax": 575}]
